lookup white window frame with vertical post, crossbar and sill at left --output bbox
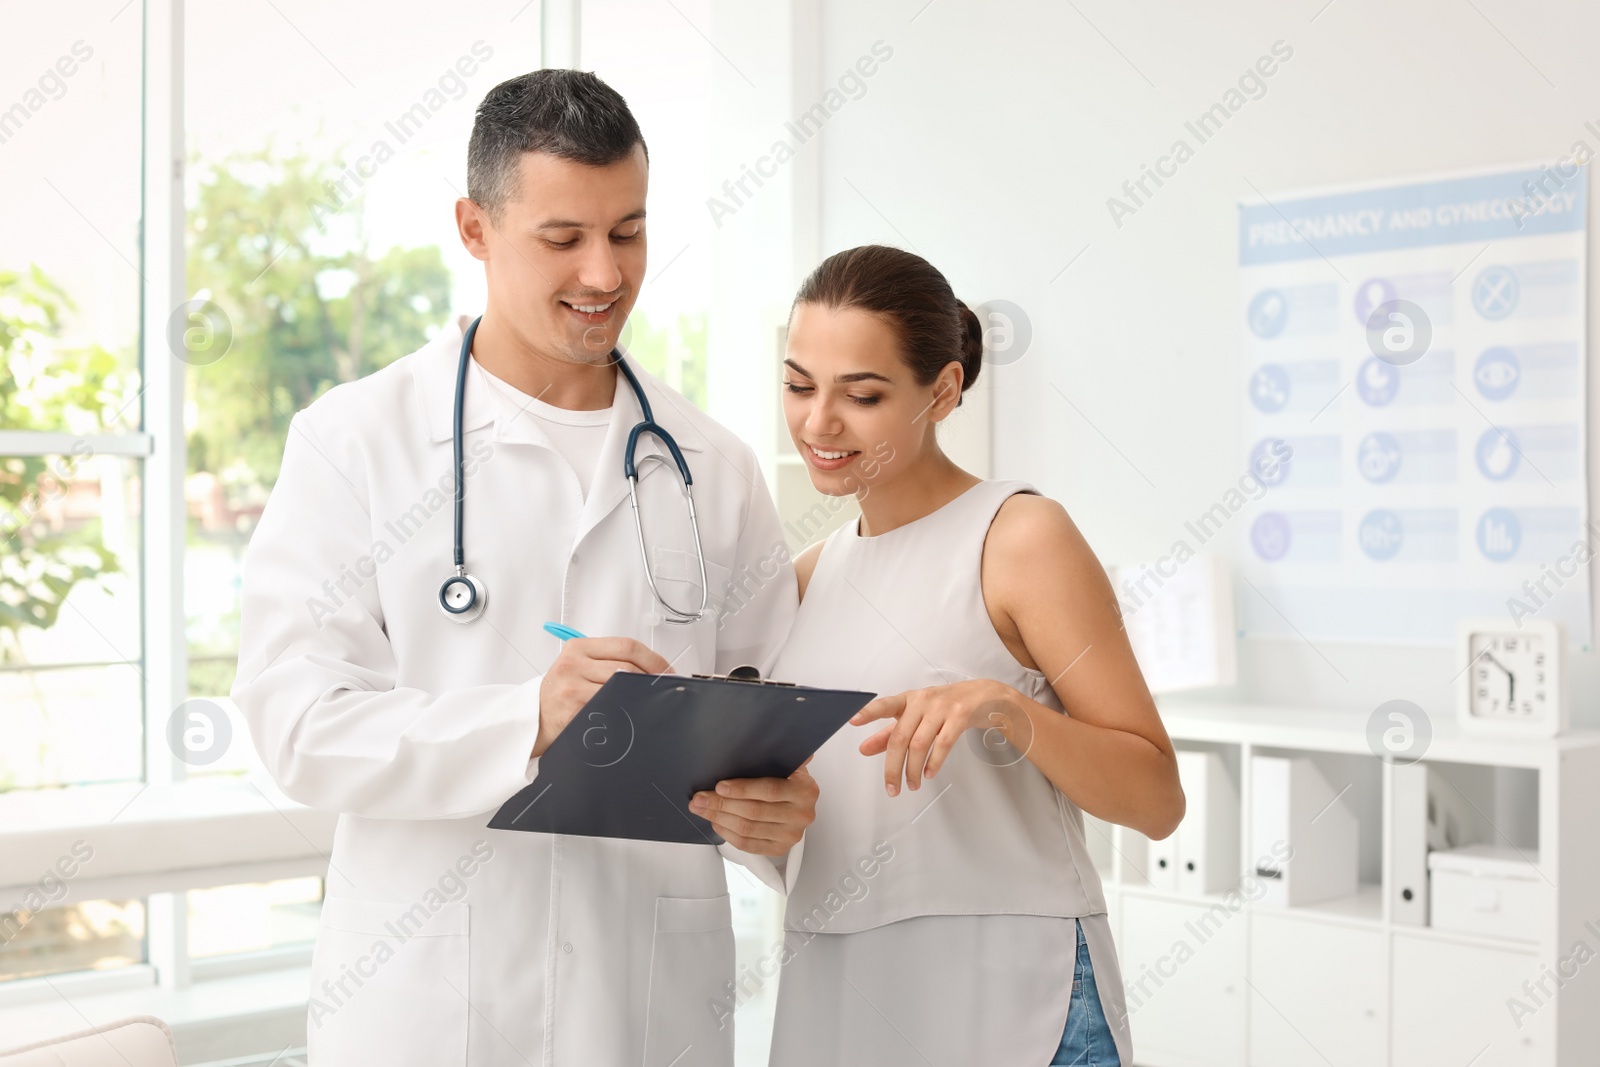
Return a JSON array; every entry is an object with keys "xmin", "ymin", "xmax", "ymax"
[{"xmin": 0, "ymin": 0, "xmax": 338, "ymax": 1009}]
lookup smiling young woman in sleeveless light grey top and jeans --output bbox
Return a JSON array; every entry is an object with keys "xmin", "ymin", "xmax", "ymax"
[{"xmin": 755, "ymin": 246, "xmax": 1184, "ymax": 1067}]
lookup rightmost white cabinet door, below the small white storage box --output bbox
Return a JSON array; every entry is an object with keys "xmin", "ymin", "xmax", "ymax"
[{"xmin": 1394, "ymin": 933, "xmax": 1554, "ymax": 1067}]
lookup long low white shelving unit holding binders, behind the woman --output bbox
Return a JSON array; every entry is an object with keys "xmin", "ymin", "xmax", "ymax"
[{"xmin": 1086, "ymin": 697, "xmax": 1600, "ymax": 1067}]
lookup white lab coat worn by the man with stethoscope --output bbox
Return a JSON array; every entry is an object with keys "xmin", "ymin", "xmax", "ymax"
[{"xmin": 234, "ymin": 326, "xmax": 798, "ymax": 1067}]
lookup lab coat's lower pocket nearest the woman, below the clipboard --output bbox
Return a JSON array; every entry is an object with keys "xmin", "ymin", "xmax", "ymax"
[{"xmin": 645, "ymin": 894, "xmax": 733, "ymax": 1067}]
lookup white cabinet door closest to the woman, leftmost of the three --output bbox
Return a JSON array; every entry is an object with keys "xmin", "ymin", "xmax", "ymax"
[{"xmin": 1117, "ymin": 893, "xmax": 1248, "ymax": 1067}]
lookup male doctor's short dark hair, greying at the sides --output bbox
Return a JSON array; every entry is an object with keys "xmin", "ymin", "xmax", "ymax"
[{"xmin": 467, "ymin": 70, "xmax": 650, "ymax": 219}]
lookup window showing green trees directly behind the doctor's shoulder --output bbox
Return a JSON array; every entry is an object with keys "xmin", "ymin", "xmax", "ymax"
[{"xmin": 184, "ymin": 0, "xmax": 539, "ymax": 710}]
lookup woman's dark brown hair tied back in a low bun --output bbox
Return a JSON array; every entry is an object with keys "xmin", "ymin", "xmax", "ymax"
[{"xmin": 789, "ymin": 245, "xmax": 984, "ymax": 405}]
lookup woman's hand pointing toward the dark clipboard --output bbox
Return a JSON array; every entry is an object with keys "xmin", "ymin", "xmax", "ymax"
[{"xmin": 850, "ymin": 678, "xmax": 1029, "ymax": 797}]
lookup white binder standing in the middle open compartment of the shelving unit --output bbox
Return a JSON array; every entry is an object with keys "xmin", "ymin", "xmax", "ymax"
[{"xmin": 1250, "ymin": 755, "xmax": 1358, "ymax": 907}]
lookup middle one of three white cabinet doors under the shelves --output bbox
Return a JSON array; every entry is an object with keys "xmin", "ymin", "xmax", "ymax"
[{"xmin": 1250, "ymin": 907, "xmax": 1388, "ymax": 1067}]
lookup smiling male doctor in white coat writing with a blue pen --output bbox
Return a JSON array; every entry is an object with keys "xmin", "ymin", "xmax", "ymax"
[{"xmin": 234, "ymin": 70, "xmax": 816, "ymax": 1067}]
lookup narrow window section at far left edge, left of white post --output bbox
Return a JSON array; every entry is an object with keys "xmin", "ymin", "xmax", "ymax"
[{"xmin": 0, "ymin": 3, "xmax": 144, "ymax": 790}]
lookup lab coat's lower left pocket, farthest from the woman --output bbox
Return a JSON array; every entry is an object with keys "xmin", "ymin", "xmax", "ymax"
[{"xmin": 307, "ymin": 896, "xmax": 472, "ymax": 1067}]
